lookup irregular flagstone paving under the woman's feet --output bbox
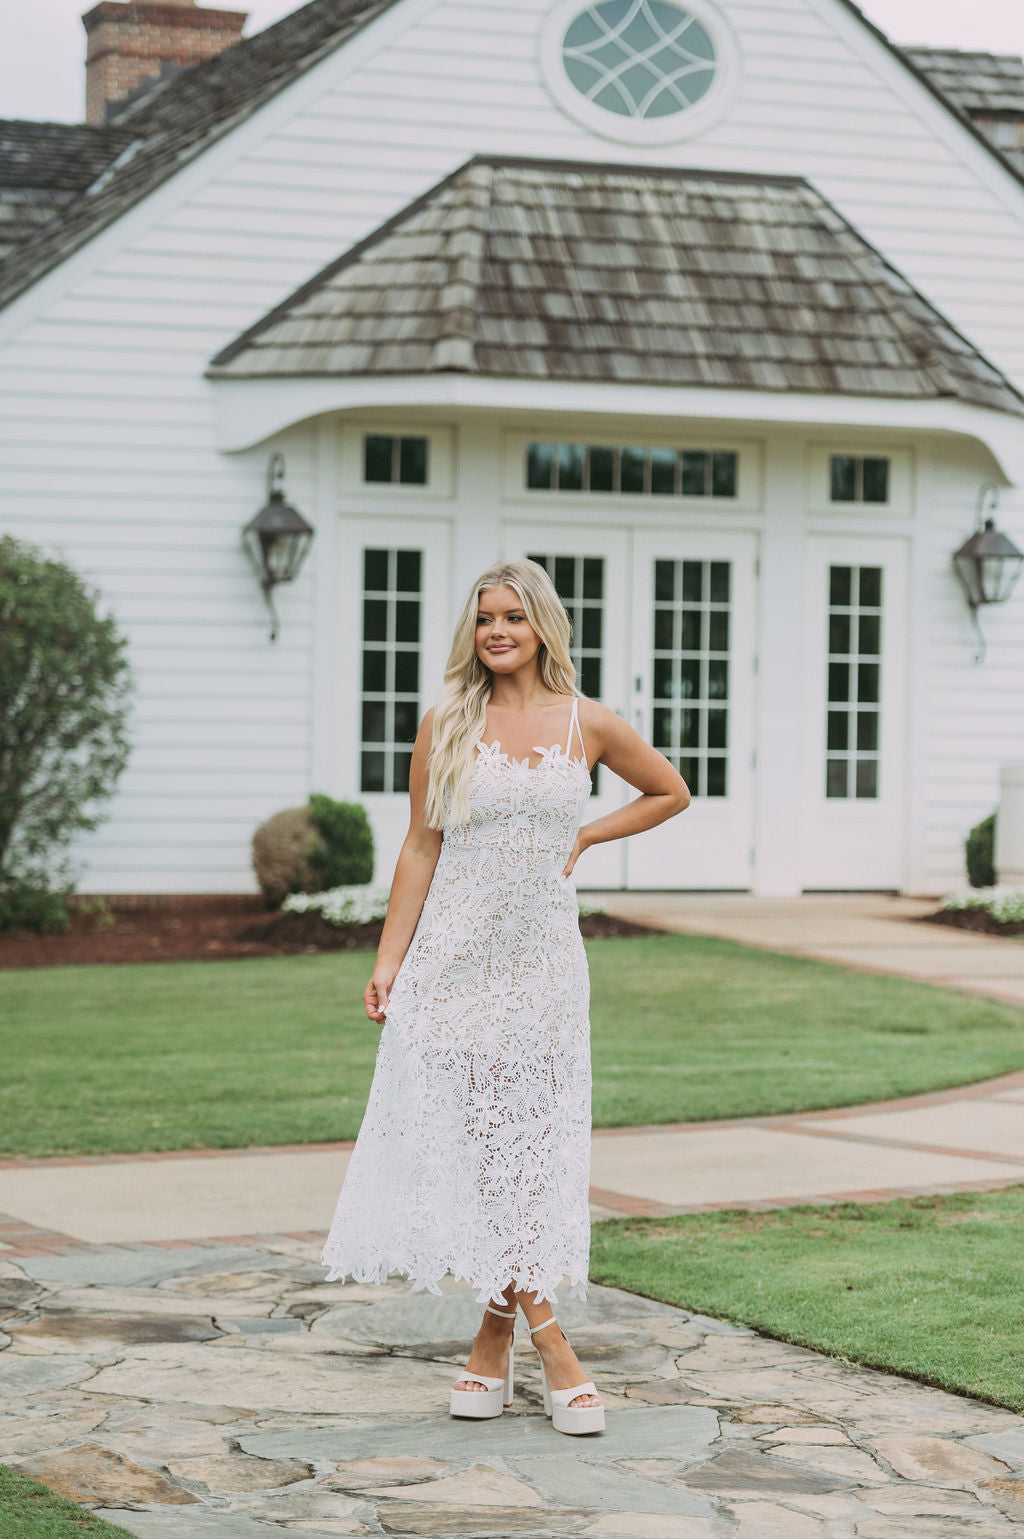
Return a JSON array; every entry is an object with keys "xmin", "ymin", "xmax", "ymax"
[{"xmin": 0, "ymin": 1236, "xmax": 1024, "ymax": 1539}]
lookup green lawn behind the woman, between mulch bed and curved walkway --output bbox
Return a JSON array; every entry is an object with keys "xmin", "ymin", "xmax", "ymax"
[{"xmin": 0, "ymin": 936, "xmax": 1024, "ymax": 1156}]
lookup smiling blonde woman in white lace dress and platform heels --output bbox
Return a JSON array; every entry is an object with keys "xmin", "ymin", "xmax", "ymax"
[{"xmin": 323, "ymin": 562, "xmax": 690, "ymax": 1433}]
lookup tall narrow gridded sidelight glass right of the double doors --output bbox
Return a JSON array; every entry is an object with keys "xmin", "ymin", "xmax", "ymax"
[{"xmin": 825, "ymin": 566, "xmax": 882, "ymax": 800}]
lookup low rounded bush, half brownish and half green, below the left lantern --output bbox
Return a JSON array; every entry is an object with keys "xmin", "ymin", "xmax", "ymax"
[{"xmin": 253, "ymin": 793, "xmax": 373, "ymax": 908}]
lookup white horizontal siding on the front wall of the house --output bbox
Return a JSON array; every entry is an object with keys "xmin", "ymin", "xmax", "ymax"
[{"xmin": 0, "ymin": 0, "xmax": 1024, "ymax": 891}]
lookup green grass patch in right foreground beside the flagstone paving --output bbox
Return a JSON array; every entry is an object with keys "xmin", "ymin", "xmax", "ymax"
[{"xmin": 590, "ymin": 1187, "xmax": 1024, "ymax": 1411}]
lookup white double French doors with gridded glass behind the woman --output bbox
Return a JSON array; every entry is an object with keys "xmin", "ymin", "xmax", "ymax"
[{"xmin": 508, "ymin": 525, "xmax": 756, "ymax": 890}]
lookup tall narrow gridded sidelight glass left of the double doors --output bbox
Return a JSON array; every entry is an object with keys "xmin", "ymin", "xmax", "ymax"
[{"xmin": 359, "ymin": 549, "xmax": 423, "ymax": 791}]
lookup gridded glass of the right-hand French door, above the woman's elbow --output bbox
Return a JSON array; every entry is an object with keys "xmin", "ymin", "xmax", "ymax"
[{"xmin": 651, "ymin": 560, "xmax": 731, "ymax": 797}]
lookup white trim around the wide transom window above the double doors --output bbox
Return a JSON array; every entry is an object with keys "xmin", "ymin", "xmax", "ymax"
[{"xmin": 502, "ymin": 426, "xmax": 762, "ymax": 516}]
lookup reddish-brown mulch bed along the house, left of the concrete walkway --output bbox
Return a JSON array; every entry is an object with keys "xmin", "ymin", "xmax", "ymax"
[{"xmin": 0, "ymin": 905, "xmax": 661, "ymax": 970}]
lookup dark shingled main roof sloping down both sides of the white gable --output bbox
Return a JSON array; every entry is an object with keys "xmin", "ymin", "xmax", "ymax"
[{"xmin": 0, "ymin": 0, "xmax": 1024, "ymax": 308}]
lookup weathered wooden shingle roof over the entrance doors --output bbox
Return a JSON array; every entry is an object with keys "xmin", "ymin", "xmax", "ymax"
[{"xmin": 208, "ymin": 159, "xmax": 1024, "ymax": 412}]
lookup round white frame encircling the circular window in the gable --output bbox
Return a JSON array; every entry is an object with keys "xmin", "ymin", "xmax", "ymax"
[{"xmin": 540, "ymin": 0, "xmax": 739, "ymax": 145}]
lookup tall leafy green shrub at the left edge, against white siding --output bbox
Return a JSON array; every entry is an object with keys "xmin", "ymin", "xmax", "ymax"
[{"xmin": 0, "ymin": 537, "xmax": 131, "ymax": 928}]
